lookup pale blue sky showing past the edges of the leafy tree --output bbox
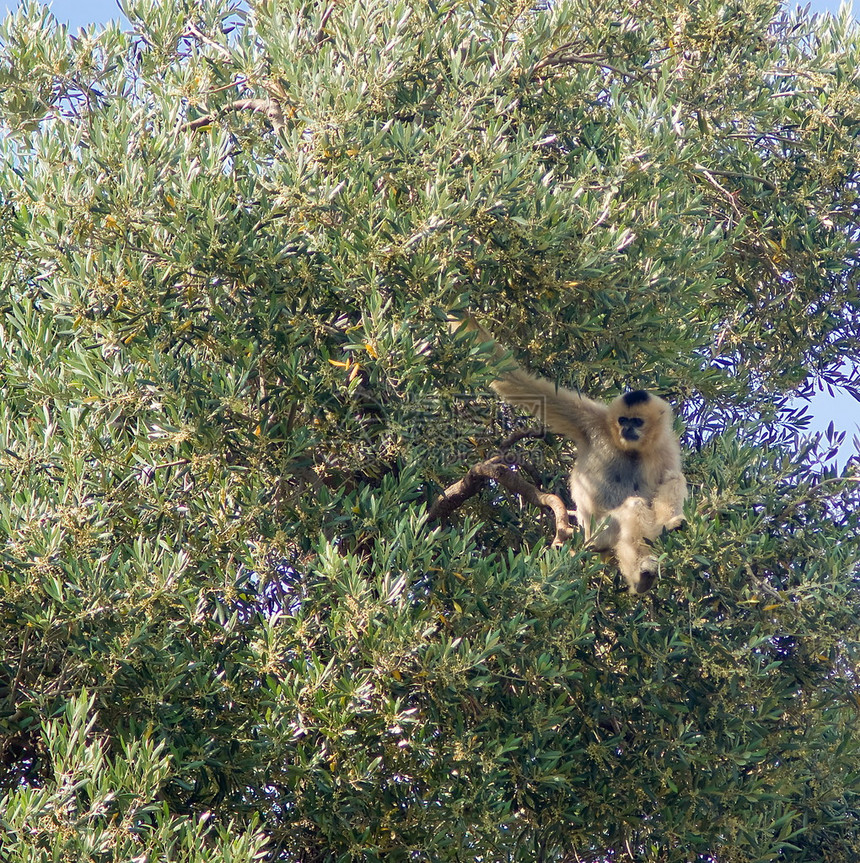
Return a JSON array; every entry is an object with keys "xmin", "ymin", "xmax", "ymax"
[{"xmin": 5, "ymin": 0, "xmax": 860, "ymax": 462}]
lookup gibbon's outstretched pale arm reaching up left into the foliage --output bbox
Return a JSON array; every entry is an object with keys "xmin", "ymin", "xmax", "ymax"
[{"xmin": 450, "ymin": 317, "xmax": 609, "ymax": 446}]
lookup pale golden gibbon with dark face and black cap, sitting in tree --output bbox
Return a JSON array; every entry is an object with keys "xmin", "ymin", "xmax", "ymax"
[{"xmin": 450, "ymin": 318, "xmax": 687, "ymax": 593}]
